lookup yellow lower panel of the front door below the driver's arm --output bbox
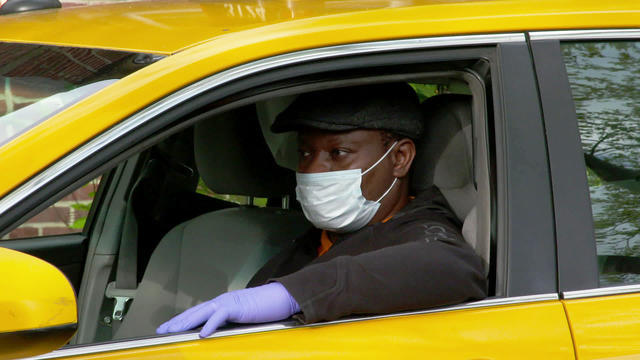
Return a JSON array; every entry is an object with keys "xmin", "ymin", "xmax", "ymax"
[{"xmin": 53, "ymin": 301, "xmax": 574, "ymax": 359}]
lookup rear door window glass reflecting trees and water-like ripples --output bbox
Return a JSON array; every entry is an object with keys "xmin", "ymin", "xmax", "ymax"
[{"xmin": 563, "ymin": 41, "xmax": 640, "ymax": 286}]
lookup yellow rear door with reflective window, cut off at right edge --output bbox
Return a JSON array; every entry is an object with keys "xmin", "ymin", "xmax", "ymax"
[{"xmin": 531, "ymin": 28, "xmax": 640, "ymax": 359}]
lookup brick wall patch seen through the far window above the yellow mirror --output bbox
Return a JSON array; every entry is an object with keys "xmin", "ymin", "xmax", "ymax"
[{"xmin": 2, "ymin": 179, "xmax": 100, "ymax": 240}]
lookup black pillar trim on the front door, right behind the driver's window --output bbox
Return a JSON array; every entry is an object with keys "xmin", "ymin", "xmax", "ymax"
[{"xmin": 492, "ymin": 42, "xmax": 558, "ymax": 296}]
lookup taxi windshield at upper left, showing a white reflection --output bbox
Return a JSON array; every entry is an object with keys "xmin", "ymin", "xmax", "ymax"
[{"xmin": 0, "ymin": 43, "xmax": 161, "ymax": 146}]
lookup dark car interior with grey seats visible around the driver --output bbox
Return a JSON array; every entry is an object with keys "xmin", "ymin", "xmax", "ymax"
[{"xmin": 0, "ymin": 71, "xmax": 501, "ymax": 345}]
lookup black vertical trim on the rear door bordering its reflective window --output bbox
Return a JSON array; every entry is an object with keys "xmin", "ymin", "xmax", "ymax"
[{"xmin": 531, "ymin": 39, "xmax": 598, "ymax": 291}]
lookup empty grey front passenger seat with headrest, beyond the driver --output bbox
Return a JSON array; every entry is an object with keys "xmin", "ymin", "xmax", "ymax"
[{"xmin": 114, "ymin": 106, "xmax": 310, "ymax": 339}]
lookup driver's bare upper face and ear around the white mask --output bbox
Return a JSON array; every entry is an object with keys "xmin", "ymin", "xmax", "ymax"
[{"xmin": 298, "ymin": 129, "xmax": 394, "ymax": 200}]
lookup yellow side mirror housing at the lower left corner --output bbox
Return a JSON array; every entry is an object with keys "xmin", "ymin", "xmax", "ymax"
[{"xmin": 0, "ymin": 247, "xmax": 78, "ymax": 359}]
